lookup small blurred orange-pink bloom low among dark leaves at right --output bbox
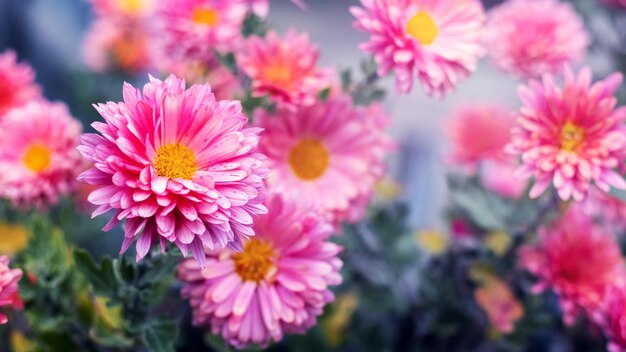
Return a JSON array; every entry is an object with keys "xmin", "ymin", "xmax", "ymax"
[{"xmin": 474, "ymin": 276, "xmax": 524, "ymax": 334}]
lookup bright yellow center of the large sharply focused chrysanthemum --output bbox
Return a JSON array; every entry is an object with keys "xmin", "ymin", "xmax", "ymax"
[{"xmin": 154, "ymin": 144, "xmax": 198, "ymax": 180}]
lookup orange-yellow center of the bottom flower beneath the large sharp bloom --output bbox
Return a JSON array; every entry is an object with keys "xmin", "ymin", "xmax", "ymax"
[{"xmin": 233, "ymin": 238, "xmax": 274, "ymax": 282}]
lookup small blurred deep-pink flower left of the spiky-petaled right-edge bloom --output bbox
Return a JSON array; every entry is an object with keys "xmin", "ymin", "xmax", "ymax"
[{"xmin": 446, "ymin": 104, "xmax": 515, "ymax": 166}]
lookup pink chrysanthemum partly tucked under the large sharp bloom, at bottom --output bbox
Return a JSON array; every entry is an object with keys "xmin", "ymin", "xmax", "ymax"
[{"xmin": 178, "ymin": 196, "xmax": 342, "ymax": 348}]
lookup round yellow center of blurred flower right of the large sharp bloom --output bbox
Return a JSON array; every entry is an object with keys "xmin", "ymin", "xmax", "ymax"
[{"xmin": 288, "ymin": 138, "xmax": 330, "ymax": 181}]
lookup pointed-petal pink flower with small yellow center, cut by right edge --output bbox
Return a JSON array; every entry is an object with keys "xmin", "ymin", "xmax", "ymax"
[{"xmin": 508, "ymin": 68, "xmax": 626, "ymax": 201}]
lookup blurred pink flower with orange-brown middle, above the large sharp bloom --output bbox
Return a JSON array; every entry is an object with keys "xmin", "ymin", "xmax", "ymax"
[{"xmin": 83, "ymin": 17, "xmax": 152, "ymax": 73}]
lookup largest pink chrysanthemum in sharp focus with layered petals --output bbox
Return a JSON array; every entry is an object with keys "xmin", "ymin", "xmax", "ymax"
[{"xmin": 79, "ymin": 76, "xmax": 266, "ymax": 266}]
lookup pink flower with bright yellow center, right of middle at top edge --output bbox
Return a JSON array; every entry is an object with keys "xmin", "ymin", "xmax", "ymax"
[{"xmin": 350, "ymin": 0, "xmax": 485, "ymax": 97}]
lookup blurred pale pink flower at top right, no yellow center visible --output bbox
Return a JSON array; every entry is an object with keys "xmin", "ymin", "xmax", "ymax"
[{"xmin": 485, "ymin": 0, "xmax": 589, "ymax": 78}]
